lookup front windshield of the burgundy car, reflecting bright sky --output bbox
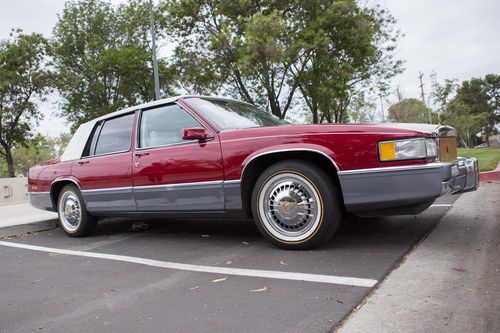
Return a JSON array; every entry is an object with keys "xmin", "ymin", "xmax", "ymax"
[{"xmin": 185, "ymin": 97, "xmax": 288, "ymax": 131}]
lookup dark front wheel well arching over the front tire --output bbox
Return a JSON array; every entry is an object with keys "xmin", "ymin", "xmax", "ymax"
[{"xmin": 241, "ymin": 151, "xmax": 344, "ymax": 217}]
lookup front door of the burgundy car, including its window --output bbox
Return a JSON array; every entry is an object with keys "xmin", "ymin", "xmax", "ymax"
[{"xmin": 133, "ymin": 104, "xmax": 225, "ymax": 212}]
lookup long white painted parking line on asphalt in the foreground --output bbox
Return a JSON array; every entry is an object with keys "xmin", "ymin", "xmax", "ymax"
[{"xmin": 0, "ymin": 241, "xmax": 378, "ymax": 287}]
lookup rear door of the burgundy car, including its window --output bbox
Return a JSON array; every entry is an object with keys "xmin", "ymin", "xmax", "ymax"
[{"xmin": 71, "ymin": 113, "xmax": 136, "ymax": 213}]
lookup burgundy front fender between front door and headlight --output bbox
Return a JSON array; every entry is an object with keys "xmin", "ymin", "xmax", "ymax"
[{"xmin": 219, "ymin": 125, "xmax": 427, "ymax": 180}]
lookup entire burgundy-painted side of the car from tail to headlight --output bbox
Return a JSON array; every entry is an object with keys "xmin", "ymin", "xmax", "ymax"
[{"xmin": 29, "ymin": 96, "xmax": 429, "ymax": 197}]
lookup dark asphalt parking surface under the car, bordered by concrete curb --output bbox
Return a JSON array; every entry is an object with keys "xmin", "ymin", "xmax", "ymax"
[{"xmin": 0, "ymin": 196, "xmax": 457, "ymax": 332}]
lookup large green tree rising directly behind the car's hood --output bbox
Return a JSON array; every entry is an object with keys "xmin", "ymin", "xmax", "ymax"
[{"xmin": 297, "ymin": 0, "xmax": 402, "ymax": 123}]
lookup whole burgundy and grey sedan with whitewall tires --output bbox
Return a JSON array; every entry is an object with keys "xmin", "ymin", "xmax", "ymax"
[{"xmin": 29, "ymin": 96, "xmax": 478, "ymax": 249}]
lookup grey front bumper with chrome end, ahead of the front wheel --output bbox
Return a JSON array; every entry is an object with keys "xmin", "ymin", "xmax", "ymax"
[{"xmin": 338, "ymin": 158, "xmax": 479, "ymax": 216}]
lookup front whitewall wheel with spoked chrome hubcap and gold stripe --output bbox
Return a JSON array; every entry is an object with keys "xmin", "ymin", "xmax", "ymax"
[{"xmin": 252, "ymin": 160, "xmax": 342, "ymax": 249}]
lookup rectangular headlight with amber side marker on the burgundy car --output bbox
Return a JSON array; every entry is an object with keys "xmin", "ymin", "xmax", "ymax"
[{"xmin": 378, "ymin": 138, "xmax": 437, "ymax": 161}]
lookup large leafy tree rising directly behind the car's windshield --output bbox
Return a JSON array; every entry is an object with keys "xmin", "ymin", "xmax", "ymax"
[{"xmin": 163, "ymin": 0, "xmax": 297, "ymax": 118}]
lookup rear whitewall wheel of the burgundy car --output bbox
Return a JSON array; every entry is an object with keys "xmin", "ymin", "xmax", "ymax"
[{"xmin": 57, "ymin": 185, "xmax": 97, "ymax": 237}]
